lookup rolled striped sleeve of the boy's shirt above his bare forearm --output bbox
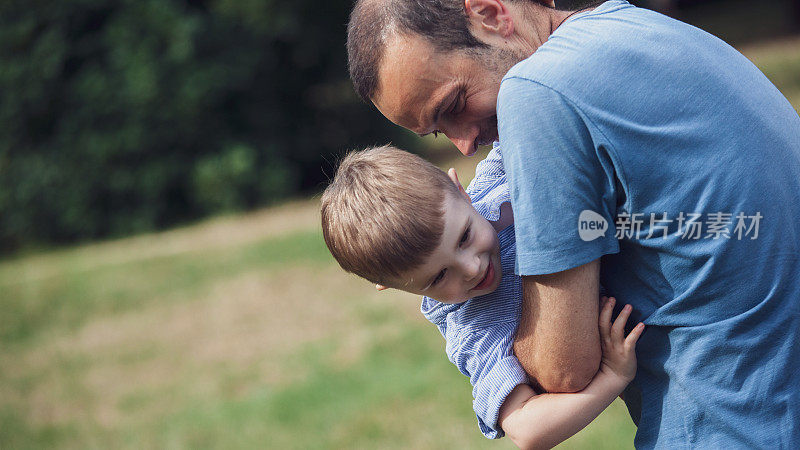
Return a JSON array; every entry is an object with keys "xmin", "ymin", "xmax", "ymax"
[{"xmin": 447, "ymin": 322, "xmax": 528, "ymax": 439}]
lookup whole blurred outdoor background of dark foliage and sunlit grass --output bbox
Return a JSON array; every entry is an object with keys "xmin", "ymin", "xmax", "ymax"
[{"xmin": 0, "ymin": 0, "xmax": 800, "ymax": 449}]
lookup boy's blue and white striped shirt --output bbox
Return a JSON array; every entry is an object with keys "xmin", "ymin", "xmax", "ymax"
[{"xmin": 420, "ymin": 148, "xmax": 528, "ymax": 438}]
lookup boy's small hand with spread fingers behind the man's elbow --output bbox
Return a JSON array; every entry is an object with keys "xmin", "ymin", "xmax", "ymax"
[{"xmin": 600, "ymin": 297, "xmax": 644, "ymax": 383}]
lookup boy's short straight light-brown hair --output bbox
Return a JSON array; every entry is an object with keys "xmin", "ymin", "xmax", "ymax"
[{"xmin": 322, "ymin": 146, "xmax": 459, "ymax": 287}]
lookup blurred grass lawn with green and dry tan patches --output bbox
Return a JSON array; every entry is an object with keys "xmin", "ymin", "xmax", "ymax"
[{"xmin": 0, "ymin": 36, "xmax": 800, "ymax": 449}]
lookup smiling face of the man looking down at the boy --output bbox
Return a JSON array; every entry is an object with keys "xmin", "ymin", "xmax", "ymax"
[{"xmin": 372, "ymin": 35, "xmax": 515, "ymax": 156}]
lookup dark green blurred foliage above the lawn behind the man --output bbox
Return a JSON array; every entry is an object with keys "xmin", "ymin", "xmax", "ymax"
[{"xmin": 0, "ymin": 0, "xmax": 798, "ymax": 254}]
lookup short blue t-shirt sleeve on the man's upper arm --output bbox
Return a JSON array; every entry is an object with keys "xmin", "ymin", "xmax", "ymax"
[{"xmin": 498, "ymin": 77, "xmax": 619, "ymax": 275}]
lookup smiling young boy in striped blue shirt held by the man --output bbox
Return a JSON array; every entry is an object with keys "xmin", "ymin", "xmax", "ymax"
[{"xmin": 322, "ymin": 147, "xmax": 644, "ymax": 448}]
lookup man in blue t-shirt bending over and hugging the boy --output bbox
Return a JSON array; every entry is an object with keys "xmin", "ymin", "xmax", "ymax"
[{"xmin": 348, "ymin": 0, "xmax": 800, "ymax": 448}]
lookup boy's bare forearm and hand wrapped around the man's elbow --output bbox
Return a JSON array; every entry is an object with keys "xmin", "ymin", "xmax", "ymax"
[{"xmin": 498, "ymin": 299, "xmax": 644, "ymax": 449}]
